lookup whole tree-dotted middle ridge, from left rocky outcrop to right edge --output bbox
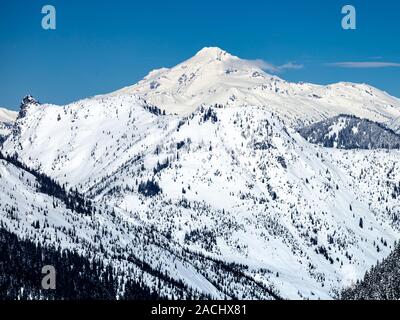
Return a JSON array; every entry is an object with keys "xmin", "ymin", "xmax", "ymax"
[{"xmin": 3, "ymin": 95, "xmax": 400, "ymax": 299}]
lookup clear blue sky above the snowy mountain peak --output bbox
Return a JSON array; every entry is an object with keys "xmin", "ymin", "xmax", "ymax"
[{"xmin": 0, "ymin": 0, "xmax": 400, "ymax": 109}]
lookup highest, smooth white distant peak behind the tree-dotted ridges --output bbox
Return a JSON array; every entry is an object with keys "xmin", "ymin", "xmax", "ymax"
[{"xmin": 111, "ymin": 48, "xmax": 400, "ymax": 130}]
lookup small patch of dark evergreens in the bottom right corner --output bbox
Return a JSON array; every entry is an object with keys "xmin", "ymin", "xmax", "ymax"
[{"xmin": 341, "ymin": 242, "xmax": 400, "ymax": 300}]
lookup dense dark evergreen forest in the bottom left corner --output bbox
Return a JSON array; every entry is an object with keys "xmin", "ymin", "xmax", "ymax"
[{"xmin": 0, "ymin": 227, "xmax": 159, "ymax": 300}]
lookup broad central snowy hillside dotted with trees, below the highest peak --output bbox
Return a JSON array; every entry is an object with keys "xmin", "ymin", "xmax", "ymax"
[{"xmin": 90, "ymin": 104, "xmax": 399, "ymax": 298}]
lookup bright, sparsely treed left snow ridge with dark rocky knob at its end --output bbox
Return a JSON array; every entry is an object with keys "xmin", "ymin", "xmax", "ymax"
[{"xmin": 3, "ymin": 95, "xmax": 175, "ymax": 184}]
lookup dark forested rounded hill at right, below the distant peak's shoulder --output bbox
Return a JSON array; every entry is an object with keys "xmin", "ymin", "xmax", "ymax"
[{"xmin": 299, "ymin": 115, "xmax": 400, "ymax": 149}]
